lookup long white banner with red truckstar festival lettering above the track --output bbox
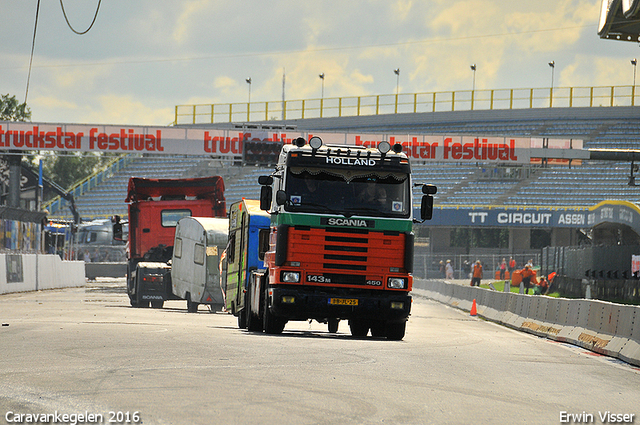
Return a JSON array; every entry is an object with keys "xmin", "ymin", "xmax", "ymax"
[{"xmin": 0, "ymin": 121, "xmax": 582, "ymax": 164}]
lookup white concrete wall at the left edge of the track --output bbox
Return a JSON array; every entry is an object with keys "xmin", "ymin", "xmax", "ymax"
[{"xmin": 0, "ymin": 254, "xmax": 86, "ymax": 294}]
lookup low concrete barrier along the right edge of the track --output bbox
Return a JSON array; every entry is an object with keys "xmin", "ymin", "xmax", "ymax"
[{"xmin": 413, "ymin": 279, "xmax": 640, "ymax": 366}]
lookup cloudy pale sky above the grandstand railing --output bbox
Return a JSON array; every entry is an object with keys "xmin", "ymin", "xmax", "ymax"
[{"xmin": 0, "ymin": 0, "xmax": 640, "ymax": 125}]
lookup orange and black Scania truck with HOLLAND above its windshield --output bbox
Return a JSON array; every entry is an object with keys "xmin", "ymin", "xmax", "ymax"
[{"xmin": 227, "ymin": 137, "xmax": 437, "ymax": 340}]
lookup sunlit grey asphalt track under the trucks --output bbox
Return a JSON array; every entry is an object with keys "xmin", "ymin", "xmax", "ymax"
[{"xmin": 0, "ymin": 281, "xmax": 640, "ymax": 425}]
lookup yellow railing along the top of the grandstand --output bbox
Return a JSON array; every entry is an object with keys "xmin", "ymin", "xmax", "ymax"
[{"xmin": 174, "ymin": 86, "xmax": 638, "ymax": 125}]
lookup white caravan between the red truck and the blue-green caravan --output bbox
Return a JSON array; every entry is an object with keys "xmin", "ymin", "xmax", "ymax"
[{"xmin": 171, "ymin": 217, "xmax": 229, "ymax": 313}]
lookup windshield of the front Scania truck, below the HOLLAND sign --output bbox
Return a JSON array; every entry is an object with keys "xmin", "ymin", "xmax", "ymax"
[{"xmin": 285, "ymin": 167, "xmax": 411, "ymax": 218}]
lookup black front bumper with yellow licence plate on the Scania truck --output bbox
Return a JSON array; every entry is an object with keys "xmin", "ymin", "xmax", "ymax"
[{"xmin": 269, "ymin": 286, "xmax": 411, "ymax": 322}]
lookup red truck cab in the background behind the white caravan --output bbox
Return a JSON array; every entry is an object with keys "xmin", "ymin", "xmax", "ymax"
[{"xmin": 113, "ymin": 176, "xmax": 227, "ymax": 308}]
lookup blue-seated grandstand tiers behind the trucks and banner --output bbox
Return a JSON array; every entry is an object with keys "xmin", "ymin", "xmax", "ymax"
[{"xmin": 46, "ymin": 106, "xmax": 640, "ymax": 218}]
